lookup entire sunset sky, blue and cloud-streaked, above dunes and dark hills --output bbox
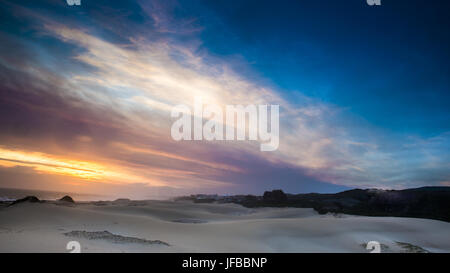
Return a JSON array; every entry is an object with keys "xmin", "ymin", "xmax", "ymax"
[{"xmin": 0, "ymin": 0, "xmax": 450, "ymax": 198}]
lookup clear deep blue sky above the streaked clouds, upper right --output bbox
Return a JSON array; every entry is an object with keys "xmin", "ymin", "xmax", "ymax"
[{"xmin": 192, "ymin": 0, "xmax": 450, "ymax": 136}]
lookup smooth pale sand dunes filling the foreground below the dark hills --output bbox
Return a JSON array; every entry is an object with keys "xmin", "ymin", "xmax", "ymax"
[{"xmin": 0, "ymin": 201, "xmax": 450, "ymax": 252}]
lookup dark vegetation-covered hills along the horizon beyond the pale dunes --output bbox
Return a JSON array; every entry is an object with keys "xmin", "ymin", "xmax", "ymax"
[{"xmin": 233, "ymin": 187, "xmax": 450, "ymax": 222}]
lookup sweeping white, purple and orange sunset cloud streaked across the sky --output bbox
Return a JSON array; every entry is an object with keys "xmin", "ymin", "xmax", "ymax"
[{"xmin": 0, "ymin": 2, "xmax": 450, "ymax": 197}]
